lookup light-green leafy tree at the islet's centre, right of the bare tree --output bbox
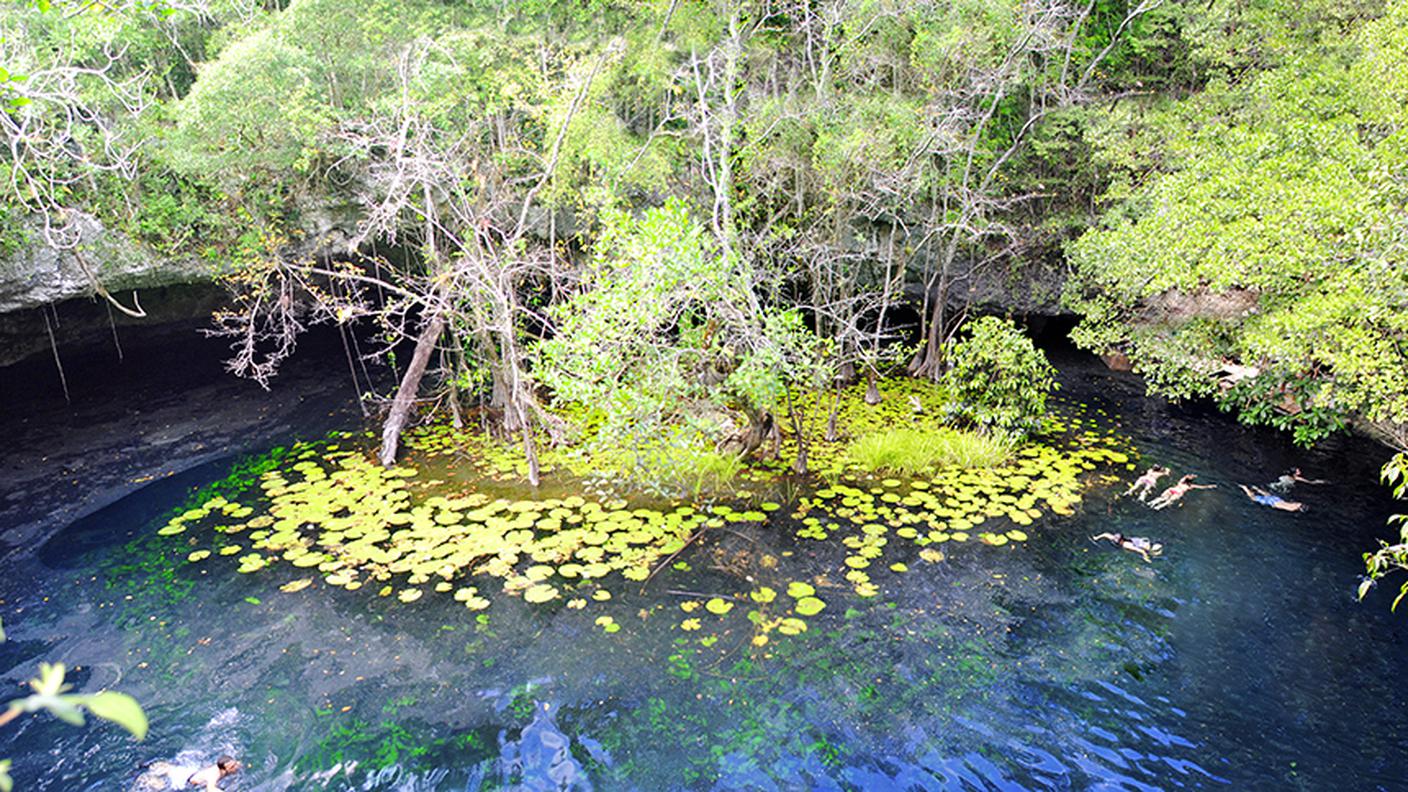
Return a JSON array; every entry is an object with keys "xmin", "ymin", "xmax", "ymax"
[{"xmin": 535, "ymin": 200, "xmax": 825, "ymax": 467}]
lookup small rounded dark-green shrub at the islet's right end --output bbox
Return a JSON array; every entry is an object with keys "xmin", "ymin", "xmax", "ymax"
[{"xmin": 943, "ymin": 316, "xmax": 1056, "ymax": 438}]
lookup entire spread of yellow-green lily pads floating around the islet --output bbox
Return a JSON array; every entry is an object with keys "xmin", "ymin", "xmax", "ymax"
[{"xmin": 158, "ymin": 380, "xmax": 1133, "ymax": 647}]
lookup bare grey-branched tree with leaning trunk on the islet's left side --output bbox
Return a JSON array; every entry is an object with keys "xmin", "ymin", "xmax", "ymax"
[{"xmin": 217, "ymin": 41, "xmax": 614, "ymax": 483}]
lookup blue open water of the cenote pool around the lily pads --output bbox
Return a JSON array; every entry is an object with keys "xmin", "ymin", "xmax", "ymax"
[{"xmin": 0, "ymin": 355, "xmax": 1408, "ymax": 791}]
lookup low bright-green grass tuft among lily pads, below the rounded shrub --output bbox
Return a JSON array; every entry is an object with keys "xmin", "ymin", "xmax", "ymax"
[{"xmin": 846, "ymin": 428, "xmax": 1012, "ymax": 475}]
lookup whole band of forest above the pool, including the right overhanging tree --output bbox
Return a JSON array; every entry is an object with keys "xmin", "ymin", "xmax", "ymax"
[{"xmin": 0, "ymin": 0, "xmax": 1408, "ymax": 583}]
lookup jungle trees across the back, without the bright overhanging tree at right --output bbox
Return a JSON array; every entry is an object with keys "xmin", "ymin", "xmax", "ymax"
[{"xmin": 0, "ymin": 0, "xmax": 1165, "ymax": 478}]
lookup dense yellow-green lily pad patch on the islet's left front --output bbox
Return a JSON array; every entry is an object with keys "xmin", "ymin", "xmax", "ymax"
[{"xmin": 158, "ymin": 451, "xmax": 732, "ymax": 610}]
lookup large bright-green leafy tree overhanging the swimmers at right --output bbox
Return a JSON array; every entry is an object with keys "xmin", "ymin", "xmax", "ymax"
[{"xmin": 1067, "ymin": 3, "xmax": 1408, "ymax": 447}]
